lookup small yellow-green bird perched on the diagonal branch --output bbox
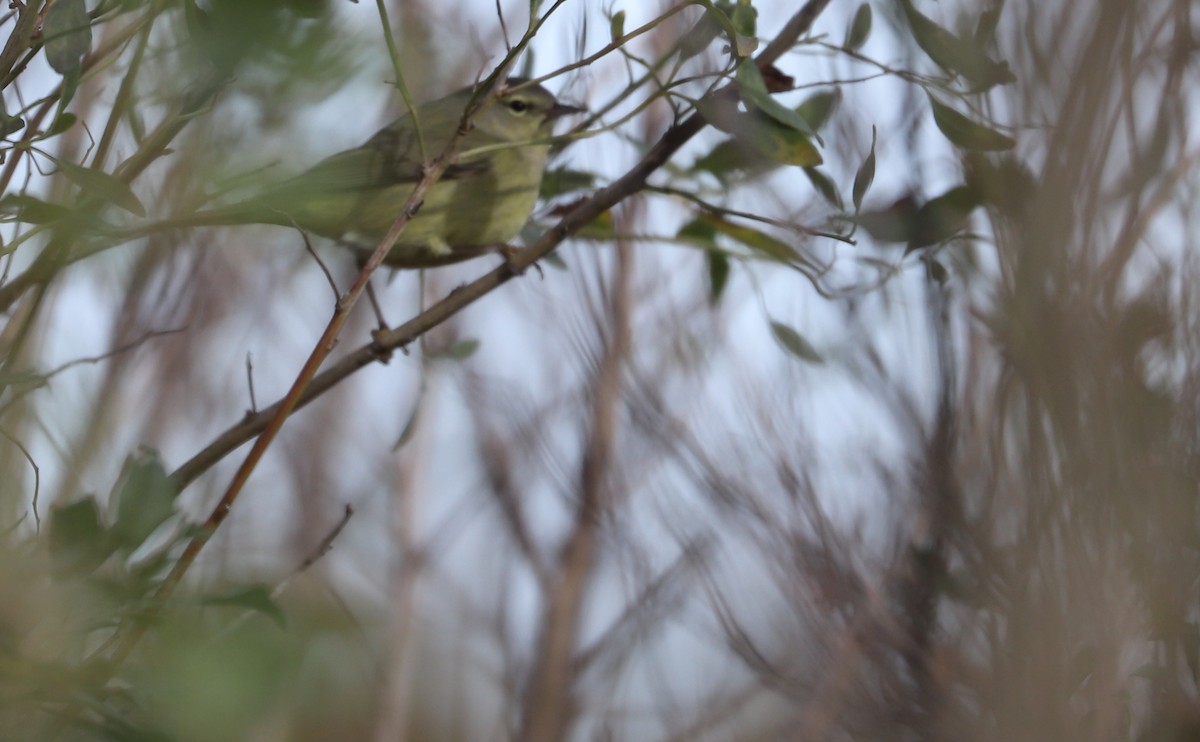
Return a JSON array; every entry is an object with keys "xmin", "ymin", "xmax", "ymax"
[{"xmin": 150, "ymin": 78, "xmax": 584, "ymax": 268}]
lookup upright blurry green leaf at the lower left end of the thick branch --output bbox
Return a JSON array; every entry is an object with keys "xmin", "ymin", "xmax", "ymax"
[{"xmin": 110, "ymin": 449, "xmax": 179, "ymax": 551}]
